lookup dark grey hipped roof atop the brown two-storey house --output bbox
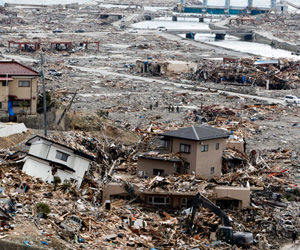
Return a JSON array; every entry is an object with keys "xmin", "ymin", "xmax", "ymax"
[{"xmin": 160, "ymin": 126, "xmax": 229, "ymax": 141}]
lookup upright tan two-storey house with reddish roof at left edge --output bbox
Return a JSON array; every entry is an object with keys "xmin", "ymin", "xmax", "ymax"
[{"xmin": 0, "ymin": 61, "xmax": 39, "ymax": 115}]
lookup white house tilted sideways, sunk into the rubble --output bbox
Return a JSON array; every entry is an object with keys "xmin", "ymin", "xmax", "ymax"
[{"xmin": 23, "ymin": 136, "xmax": 94, "ymax": 187}]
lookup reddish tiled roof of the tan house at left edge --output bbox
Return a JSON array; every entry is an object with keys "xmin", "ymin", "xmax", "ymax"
[{"xmin": 0, "ymin": 61, "xmax": 40, "ymax": 76}]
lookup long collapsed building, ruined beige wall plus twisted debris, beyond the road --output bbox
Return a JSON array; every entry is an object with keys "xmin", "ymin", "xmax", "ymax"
[{"xmin": 134, "ymin": 58, "xmax": 300, "ymax": 90}]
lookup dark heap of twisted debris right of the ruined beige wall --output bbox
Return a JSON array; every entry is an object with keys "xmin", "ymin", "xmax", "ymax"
[{"xmin": 187, "ymin": 59, "xmax": 300, "ymax": 89}]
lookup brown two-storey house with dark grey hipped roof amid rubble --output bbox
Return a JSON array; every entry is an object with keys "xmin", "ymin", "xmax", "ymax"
[{"xmin": 138, "ymin": 126, "xmax": 229, "ymax": 178}]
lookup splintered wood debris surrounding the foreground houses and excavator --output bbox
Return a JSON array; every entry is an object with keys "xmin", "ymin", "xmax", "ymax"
[{"xmin": 1, "ymin": 118, "xmax": 300, "ymax": 249}]
